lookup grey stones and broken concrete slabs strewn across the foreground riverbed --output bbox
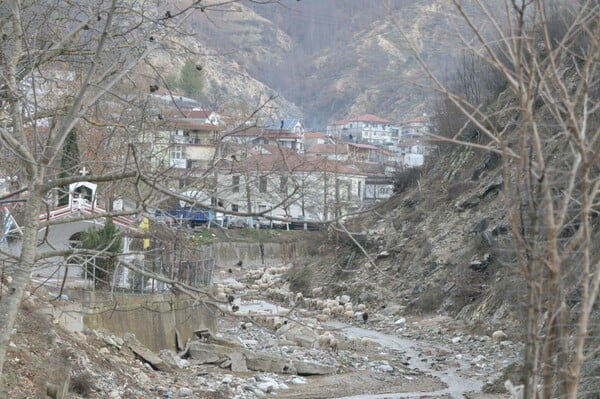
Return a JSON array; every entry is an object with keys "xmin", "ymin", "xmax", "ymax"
[{"xmin": 2, "ymin": 270, "xmax": 521, "ymax": 399}]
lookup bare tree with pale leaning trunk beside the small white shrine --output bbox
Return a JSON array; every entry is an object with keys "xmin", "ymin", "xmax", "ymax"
[{"xmin": 0, "ymin": 0, "xmax": 288, "ymax": 390}]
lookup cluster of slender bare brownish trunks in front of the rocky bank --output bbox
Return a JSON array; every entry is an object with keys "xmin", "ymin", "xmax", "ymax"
[{"xmin": 398, "ymin": 0, "xmax": 600, "ymax": 399}]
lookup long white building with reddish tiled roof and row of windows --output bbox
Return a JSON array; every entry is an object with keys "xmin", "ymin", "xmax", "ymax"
[{"xmin": 215, "ymin": 148, "xmax": 368, "ymax": 220}]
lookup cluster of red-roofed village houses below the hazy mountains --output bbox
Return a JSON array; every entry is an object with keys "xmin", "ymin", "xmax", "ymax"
[{"xmin": 144, "ymin": 94, "xmax": 435, "ymax": 225}]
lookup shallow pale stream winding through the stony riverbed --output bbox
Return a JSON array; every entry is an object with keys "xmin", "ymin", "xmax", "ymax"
[{"xmin": 327, "ymin": 322, "xmax": 483, "ymax": 399}]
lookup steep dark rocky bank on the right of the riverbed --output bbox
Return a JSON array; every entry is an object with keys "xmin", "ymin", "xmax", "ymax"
[{"xmin": 292, "ymin": 144, "xmax": 524, "ymax": 330}]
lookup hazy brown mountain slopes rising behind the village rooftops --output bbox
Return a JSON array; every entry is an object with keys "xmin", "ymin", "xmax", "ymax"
[{"xmin": 164, "ymin": 0, "xmax": 474, "ymax": 128}]
